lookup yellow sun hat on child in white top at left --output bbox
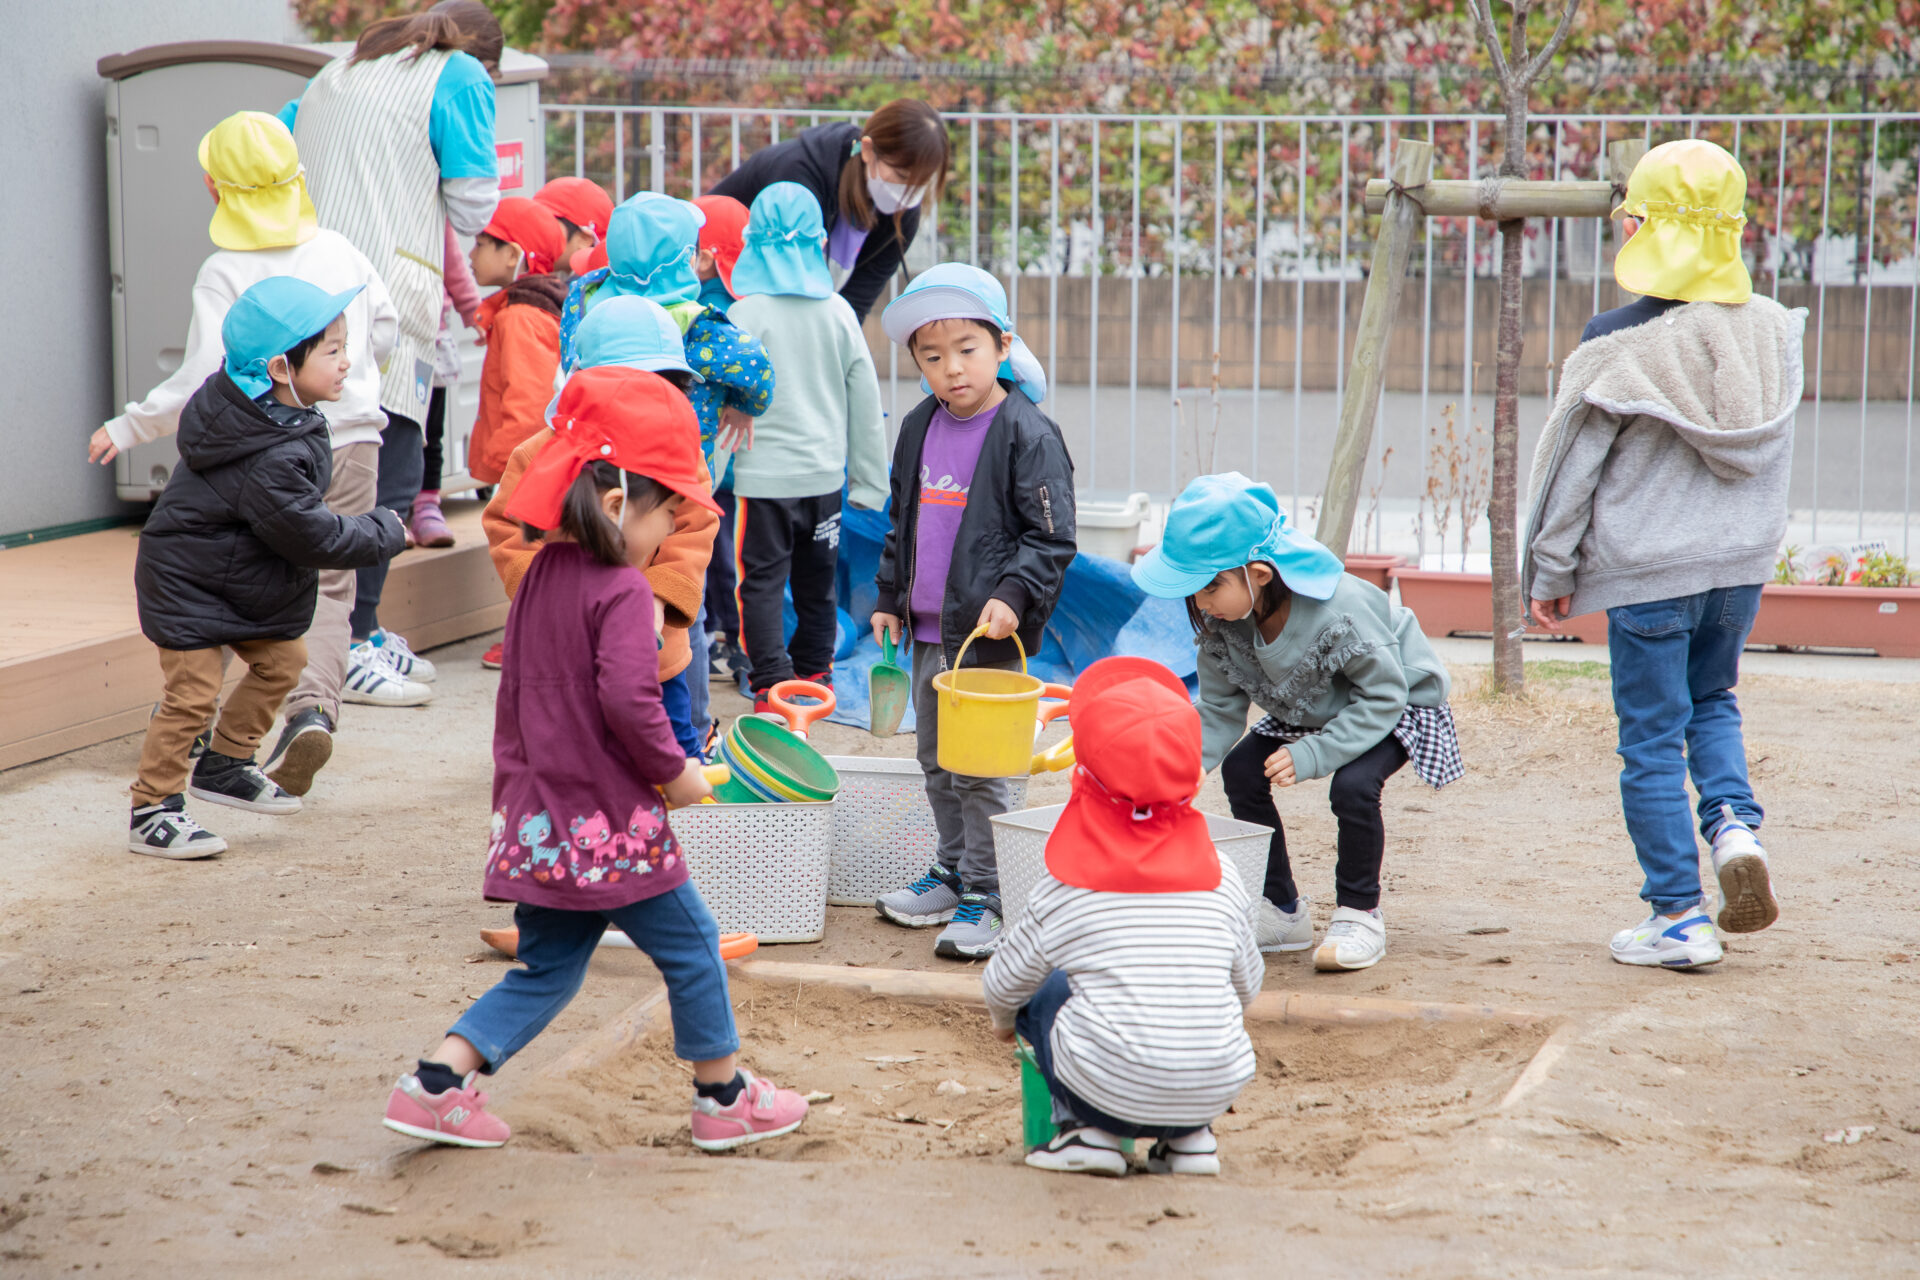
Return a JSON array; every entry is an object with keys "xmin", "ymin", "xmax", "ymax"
[{"xmin": 200, "ymin": 111, "xmax": 321, "ymax": 249}]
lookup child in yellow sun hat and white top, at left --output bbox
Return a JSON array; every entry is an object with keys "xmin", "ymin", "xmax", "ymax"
[{"xmin": 86, "ymin": 111, "xmax": 403, "ymax": 794}]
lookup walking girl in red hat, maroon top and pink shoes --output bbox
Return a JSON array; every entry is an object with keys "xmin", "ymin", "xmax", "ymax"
[{"xmin": 384, "ymin": 367, "xmax": 806, "ymax": 1151}]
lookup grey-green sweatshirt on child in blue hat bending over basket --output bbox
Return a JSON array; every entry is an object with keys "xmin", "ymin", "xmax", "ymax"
[{"xmin": 1196, "ymin": 574, "xmax": 1448, "ymax": 781}]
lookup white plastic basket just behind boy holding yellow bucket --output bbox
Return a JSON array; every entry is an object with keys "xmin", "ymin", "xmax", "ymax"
[{"xmin": 828, "ymin": 756, "xmax": 1027, "ymax": 906}]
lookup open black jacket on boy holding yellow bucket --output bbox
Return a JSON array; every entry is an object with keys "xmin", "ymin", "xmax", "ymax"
[{"xmin": 874, "ymin": 380, "xmax": 1073, "ymax": 664}]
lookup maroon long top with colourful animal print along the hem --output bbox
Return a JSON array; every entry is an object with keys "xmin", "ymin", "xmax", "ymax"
[{"xmin": 486, "ymin": 543, "xmax": 687, "ymax": 912}]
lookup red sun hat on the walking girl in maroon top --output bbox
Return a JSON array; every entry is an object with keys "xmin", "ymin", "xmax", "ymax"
[{"xmin": 507, "ymin": 365, "xmax": 720, "ymax": 530}]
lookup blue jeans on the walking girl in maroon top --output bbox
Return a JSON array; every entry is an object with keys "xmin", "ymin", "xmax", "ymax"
[{"xmin": 447, "ymin": 885, "xmax": 739, "ymax": 1075}]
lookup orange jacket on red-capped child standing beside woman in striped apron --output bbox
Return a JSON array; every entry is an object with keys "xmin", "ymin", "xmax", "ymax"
[{"xmin": 467, "ymin": 276, "xmax": 566, "ymax": 484}]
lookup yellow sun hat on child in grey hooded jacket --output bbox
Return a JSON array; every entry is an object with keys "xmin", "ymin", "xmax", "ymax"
[{"xmin": 1613, "ymin": 138, "xmax": 1753, "ymax": 303}]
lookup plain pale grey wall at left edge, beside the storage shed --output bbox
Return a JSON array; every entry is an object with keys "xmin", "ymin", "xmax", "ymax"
[{"xmin": 0, "ymin": 0, "xmax": 296, "ymax": 541}]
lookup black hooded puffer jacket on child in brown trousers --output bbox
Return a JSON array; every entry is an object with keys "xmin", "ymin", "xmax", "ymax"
[{"xmin": 132, "ymin": 370, "xmax": 407, "ymax": 649}]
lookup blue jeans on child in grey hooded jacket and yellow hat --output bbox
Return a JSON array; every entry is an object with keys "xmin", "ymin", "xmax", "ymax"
[{"xmin": 1607, "ymin": 587, "xmax": 1763, "ymax": 913}]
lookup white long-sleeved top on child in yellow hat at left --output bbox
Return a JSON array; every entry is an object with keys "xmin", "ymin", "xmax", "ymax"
[{"xmin": 106, "ymin": 228, "xmax": 399, "ymax": 451}]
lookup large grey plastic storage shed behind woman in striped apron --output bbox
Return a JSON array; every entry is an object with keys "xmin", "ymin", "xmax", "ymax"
[{"xmin": 98, "ymin": 40, "xmax": 547, "ymax": 503}]
